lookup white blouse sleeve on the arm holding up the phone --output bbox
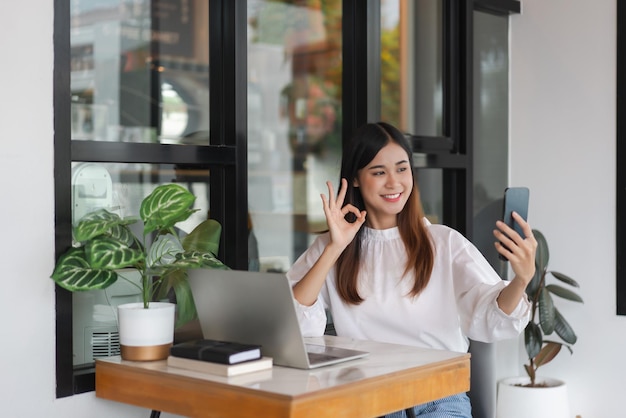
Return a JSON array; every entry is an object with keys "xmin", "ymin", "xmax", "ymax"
[{"xmin": 453, "ymin": 232, "xmax": 530, "ymax": 342}]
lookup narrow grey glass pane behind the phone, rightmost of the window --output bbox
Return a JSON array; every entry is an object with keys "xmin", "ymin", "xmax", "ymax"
[{"xmin": 472, "ymin": 12, "xmax": 509, "ymax": 278}]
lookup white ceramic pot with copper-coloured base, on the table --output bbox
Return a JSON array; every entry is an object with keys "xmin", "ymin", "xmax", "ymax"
[{"xmin": 117, "ymin": 302, "xmax": 176, "ymax": 361}]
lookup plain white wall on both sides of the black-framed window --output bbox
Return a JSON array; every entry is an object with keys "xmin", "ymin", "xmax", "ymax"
[{"xmin": 0, "ymin": 0, "xmax": 626, "ymax": 418}]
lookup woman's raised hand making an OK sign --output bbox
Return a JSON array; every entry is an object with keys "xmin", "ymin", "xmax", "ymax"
[{"xmin": 321, "ymin": 179, "xmax": 366, "ymax": 251}]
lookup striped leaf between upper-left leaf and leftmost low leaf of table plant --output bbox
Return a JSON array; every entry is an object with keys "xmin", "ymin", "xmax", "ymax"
[{"xmin": 85, "ymin": 238, "xmax": 144, "ymax": 270}]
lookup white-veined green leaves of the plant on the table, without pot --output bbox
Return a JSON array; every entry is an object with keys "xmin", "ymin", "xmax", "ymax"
[{"xmin": 51, "ymin": 184, "xmax": 228, "ymax": 325}]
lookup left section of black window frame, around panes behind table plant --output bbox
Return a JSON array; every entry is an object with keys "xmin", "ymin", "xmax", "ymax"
[{"xmin": 54, "ymin": 0, "xmax": 248, "ymax": 398}]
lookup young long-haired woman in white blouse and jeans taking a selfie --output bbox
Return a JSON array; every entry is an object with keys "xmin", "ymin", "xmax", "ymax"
[{"xmin": 287, "ymin": 123, "xmax": 537, "ymax": 417}]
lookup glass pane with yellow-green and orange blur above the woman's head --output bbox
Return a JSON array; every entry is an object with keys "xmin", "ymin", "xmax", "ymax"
[{"xmin": 381, "ymin": 0, "xmax": 444, "ymax": 136}]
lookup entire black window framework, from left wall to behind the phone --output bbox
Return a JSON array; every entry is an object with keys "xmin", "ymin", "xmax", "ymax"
[{"xmin": 53, "ymin": 0, "xmax": 520, "ymax": 398}]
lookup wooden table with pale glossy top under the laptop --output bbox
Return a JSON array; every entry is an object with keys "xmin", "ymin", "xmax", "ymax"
[{"xmin": 96, "ymin": 336, "xmax": 470, "ymax": 418}]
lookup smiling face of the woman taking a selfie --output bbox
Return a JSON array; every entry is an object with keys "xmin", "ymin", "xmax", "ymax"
[{"xmin": 354, "ymin": 141, "xmax": 413, "ymax": 229}]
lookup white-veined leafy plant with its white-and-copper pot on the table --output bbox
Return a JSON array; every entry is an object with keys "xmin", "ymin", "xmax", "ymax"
[{"xmin": 51, "ymin": 184, "xmax": 227, "ymax": 360}]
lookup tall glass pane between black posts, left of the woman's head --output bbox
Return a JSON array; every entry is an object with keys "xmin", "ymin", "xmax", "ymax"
[{"xmin": 248, "ymin": 0, "xmax": 342, "ymax": 271}]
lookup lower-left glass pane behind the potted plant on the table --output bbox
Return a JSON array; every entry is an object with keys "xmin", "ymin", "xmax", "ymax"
[{"xmin": 72, "ymin": 163, "xmax": 209, "ymax": 366}]
